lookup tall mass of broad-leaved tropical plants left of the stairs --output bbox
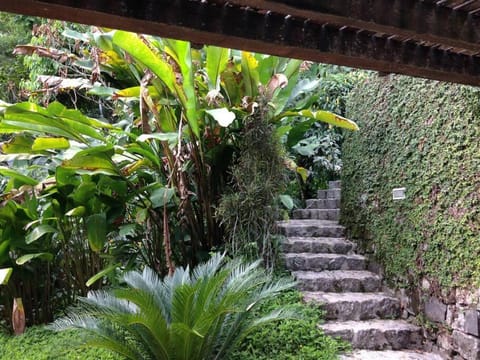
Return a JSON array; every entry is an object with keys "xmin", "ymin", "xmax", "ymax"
[{"xmin": 0, "ymin": 24, "xmax": 356, "ymax": 323}]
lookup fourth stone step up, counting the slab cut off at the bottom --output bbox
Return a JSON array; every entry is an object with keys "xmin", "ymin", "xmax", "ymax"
[{"xmin": 293, "ymin": 270, "xmax": 382, "ymax": 292}]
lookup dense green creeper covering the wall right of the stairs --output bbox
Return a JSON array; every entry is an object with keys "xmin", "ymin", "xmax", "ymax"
[{"xmin": 342, "ymin": 76, "xmax": 480, "ymax": 296}]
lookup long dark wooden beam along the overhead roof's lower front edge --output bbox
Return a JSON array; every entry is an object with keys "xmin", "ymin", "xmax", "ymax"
[{"xmin": 0, "ymin": 0, "xmax": 480, "ymax": 86}]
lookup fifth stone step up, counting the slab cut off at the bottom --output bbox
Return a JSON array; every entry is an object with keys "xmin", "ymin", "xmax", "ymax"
[{"xmin": 284, "ymin": 253, "xmax": 367, "ymax": 271}]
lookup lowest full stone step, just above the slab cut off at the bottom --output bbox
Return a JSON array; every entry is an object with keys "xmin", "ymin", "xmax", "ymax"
[{"xmin": 319, "ymin": 320, "xmax": 422, "ymax": 350}]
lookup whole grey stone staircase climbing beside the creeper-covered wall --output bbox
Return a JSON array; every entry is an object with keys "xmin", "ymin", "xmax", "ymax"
[{"xmin": 279, "ymin": 181, "xmax": 441, "ymax": 360}]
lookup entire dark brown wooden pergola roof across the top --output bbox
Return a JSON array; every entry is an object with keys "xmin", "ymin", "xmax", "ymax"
[{"xmin": 0, "ymin": 0, "xmax": 480, "ymax": 86}]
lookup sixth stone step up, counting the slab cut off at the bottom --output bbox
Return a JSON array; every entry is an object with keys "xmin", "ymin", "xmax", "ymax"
[{"xmin": 282, "ymin": 237, "xmax": 354, "ymax": 254}]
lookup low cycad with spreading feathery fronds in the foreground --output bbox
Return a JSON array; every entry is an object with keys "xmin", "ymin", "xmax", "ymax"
[{"xmin": 53, "ymin": 254, "xmax": 294, "ymax": 360}]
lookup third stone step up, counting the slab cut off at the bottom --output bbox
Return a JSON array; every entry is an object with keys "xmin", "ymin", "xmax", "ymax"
[{"xmin": 303, "ymin": 292, "xmax": 400, "ymax": 321}]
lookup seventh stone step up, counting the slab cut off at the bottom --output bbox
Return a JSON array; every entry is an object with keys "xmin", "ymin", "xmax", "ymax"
[{"xmin": 277, "ymin": 219, "xmax": 345, "ymax": 238}]
